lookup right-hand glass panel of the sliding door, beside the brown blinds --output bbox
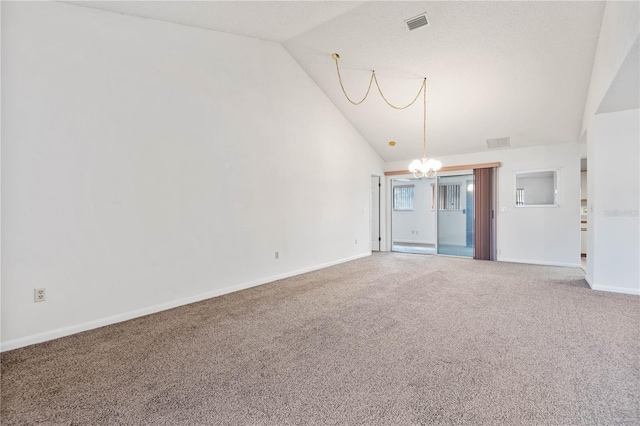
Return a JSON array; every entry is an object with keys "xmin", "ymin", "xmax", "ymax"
[{"xmin": 437, "ymin": 174, "xmax": 475, "ymax": 257}]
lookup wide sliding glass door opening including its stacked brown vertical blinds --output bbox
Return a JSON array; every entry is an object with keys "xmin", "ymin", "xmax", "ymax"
[{"xmin": 388, "ymin": 163, "xmax": 500, "ymax": 260}]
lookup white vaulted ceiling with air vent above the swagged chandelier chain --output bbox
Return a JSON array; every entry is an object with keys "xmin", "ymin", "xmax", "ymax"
[{"xmin": 67, "ymin": 1, "xmax": 604, "ymax": 161}]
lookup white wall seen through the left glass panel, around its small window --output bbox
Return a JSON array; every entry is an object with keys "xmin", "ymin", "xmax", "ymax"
[{"xmin": 389, "ymin": 179, "xmax": 436, "ymax": 244}]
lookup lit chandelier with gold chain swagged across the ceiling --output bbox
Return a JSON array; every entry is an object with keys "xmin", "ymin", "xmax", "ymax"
[{"xmin": 331, "ymin": 53, "xmax": 442, "ymax": 178}]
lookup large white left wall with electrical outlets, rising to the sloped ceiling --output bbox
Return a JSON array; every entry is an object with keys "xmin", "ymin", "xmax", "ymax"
[{"xmin": 2, "ymin": 2, "xmax": 383, "ymax": 350}]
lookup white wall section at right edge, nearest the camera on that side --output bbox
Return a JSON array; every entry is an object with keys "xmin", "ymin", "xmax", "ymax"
[{"xmin": 587, "ymin": 109, "xmax": 640, "ymax": 295}]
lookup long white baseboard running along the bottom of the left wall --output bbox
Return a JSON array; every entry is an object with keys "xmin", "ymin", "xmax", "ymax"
[{"xmin": 0, "ymin": 252, "xmax": 371, "ymax": 352}]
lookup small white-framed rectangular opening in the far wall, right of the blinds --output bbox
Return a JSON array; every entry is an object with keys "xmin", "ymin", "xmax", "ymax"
[{"xmin": 515, "ymin": 170, "xmax": 558, "ymax": 207}]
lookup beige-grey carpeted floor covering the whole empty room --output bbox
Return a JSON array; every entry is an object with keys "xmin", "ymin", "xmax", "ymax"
[{"xmin": 0, "ymin": 253, "xmax": 640, "ymax": 426}]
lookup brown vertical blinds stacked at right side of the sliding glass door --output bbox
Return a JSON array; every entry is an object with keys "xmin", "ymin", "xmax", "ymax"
[{"xmin": 473, "ymin": 168, "xmax": 495, "ymax": 260}]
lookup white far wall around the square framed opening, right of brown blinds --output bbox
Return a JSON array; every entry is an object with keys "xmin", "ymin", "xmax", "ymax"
[{"xmin": 385, "ymin": 143, "xmax": 580, "ymax": 267}]
